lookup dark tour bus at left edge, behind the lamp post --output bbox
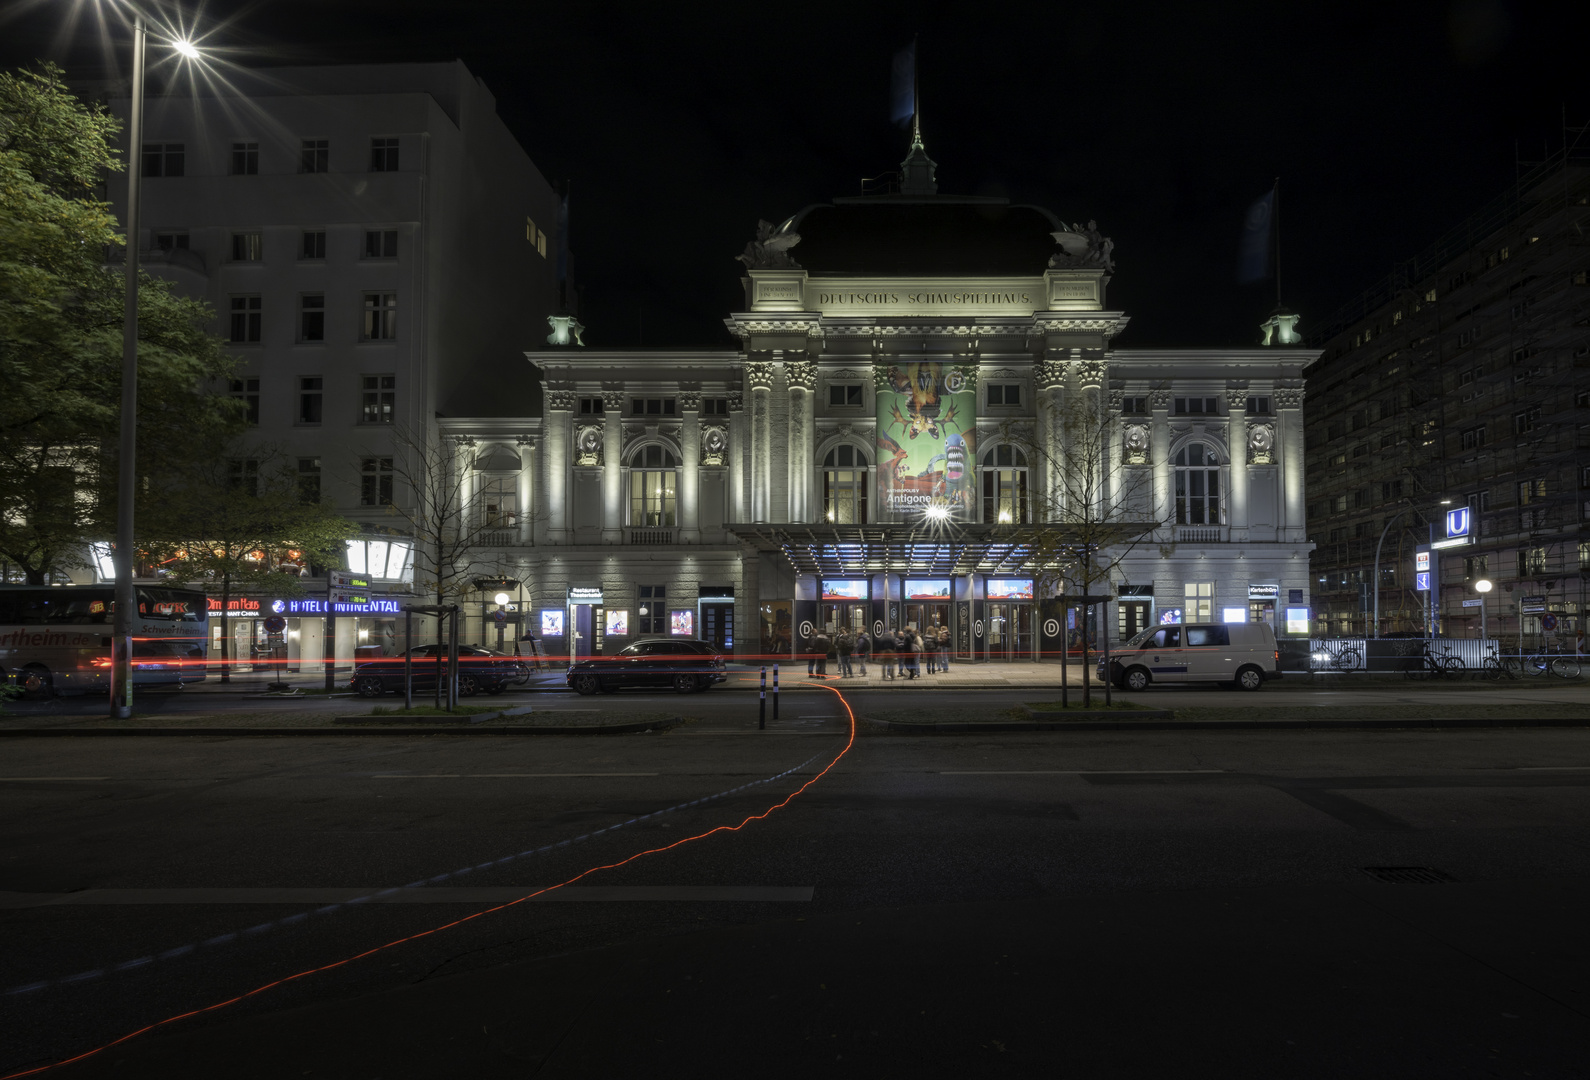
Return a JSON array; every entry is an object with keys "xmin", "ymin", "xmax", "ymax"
[{"xmin": 0, "ymin": 584, "xmax": 208, "ymax": 700}]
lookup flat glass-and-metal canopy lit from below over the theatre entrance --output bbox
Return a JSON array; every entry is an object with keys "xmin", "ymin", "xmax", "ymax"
[{"xmin": 731, "ymin": 522, "xmax": 1158, "ymax": 577}]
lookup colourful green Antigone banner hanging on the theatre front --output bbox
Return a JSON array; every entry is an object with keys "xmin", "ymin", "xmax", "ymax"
[{"xmin": 876, "ymin": 363, "xmax": 978, "ymax": 520}]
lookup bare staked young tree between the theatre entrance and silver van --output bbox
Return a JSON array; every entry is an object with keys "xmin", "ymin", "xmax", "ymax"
[{"xmin": 1000, "ymin": 377, "xmax": 1169, "ymax": 705}]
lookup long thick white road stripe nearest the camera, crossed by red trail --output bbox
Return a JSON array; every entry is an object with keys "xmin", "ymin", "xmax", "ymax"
[{"xmin": 0, "ymin": 884, "xmax": 814, "ymax": 908}]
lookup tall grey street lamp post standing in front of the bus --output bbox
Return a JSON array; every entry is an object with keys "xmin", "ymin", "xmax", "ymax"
[{"xmin": 110, "ymin": 11, "xmax": 149, "ymax": 721}]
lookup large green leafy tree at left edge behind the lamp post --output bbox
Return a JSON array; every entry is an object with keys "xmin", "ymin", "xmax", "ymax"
[{"xmin": 0, "ymin": 64, "xmax": 242, "ymax": 584}]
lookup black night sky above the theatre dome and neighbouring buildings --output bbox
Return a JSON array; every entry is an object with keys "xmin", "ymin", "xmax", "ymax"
[{"xmin": 0, "ymin": 0, "xmax": 1590, "ymax": 347}]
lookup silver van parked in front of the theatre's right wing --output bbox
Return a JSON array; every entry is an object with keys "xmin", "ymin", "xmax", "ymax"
[{"xmin": 1099, "ymin": 622, "xmax": 1282, "ymax": 690}]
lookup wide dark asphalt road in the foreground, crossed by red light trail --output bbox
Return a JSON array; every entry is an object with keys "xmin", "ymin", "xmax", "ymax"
[{"xmin": 0, "ymin": 690, "xmax": 1590, "ymax": 1080}]
